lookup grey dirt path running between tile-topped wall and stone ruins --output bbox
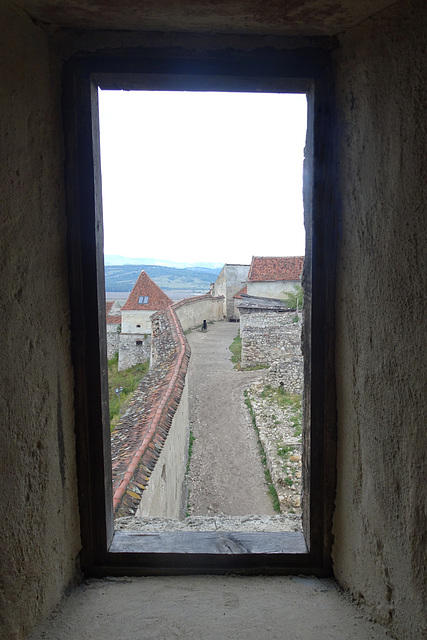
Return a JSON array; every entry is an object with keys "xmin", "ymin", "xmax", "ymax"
[{"xmin": 187, "ymin": 322, "xmax": 274, "ymax": 516}]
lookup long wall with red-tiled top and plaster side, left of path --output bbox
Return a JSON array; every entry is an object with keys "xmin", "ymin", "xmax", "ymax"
[{"xmin": 111, "ymin": 307, "xmax": 190, "ymax": 517}]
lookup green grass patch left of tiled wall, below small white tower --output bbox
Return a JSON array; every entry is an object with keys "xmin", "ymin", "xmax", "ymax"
[{"xmin": 108, "ymin": 353, "xmax": 150, "ymax": 431}]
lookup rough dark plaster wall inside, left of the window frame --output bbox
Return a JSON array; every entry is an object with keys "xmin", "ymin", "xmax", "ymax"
[{"xmin": 0, "ymin": 3, "xmax": 80, "ymax": 640}]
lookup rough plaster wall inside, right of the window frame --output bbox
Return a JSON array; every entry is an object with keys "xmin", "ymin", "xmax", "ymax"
[{"xmin": 333, "ymin": 1, "xmax": 427, "ymax": 638}]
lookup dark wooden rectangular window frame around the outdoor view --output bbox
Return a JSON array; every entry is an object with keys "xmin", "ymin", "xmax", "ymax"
[{"xmin": 63, "ymin": 42, "xmax": 338, "ymax": 576}]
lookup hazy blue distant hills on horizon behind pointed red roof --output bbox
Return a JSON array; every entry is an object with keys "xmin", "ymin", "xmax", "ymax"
[{"xmin": 105, "ymin": 264, "xmax": 222, "ymax": 298}]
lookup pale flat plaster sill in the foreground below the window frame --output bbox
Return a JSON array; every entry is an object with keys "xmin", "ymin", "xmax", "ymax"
[{"xmin": 31, "ymin": 576, "xmax": 389, "ymax": 640}]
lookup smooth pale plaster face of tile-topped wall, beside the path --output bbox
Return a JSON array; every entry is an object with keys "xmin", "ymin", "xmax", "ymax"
[{"xmin": 135, "ymin": 381, "xmax": 190, "ymax": 519}]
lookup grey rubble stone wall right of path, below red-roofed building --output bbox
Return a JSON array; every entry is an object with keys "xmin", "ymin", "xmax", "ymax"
[{"xmin": 240, "ymin": 306, "xmax": 302, "ymax": 369}]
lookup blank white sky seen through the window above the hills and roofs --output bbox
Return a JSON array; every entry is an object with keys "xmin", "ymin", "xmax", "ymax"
[{"xmin": 99, "ymin": 91, "xmax": 307, "ymax": 264}]
